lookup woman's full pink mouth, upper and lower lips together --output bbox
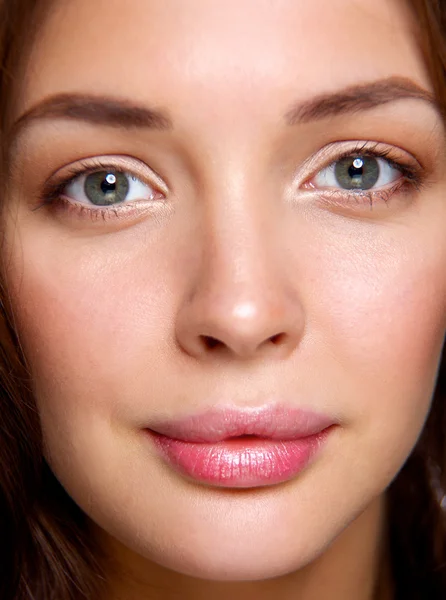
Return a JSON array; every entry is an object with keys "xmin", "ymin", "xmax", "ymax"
[{"xmin": 145, "ymin": 405, "xmax": 338, "ymax": 488}]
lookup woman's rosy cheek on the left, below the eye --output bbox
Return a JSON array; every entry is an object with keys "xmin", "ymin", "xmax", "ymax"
[{"xmin": 3, "ymin": 225, "xmax": 181, "ymax": 428}]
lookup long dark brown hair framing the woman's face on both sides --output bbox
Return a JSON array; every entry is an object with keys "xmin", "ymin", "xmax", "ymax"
[{"xmin": 0, "ymin": 0, "xmax": 446, "ymax": 600}]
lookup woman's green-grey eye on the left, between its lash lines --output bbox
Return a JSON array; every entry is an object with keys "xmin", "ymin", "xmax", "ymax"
[{"xmin": 61, "ymin": 169, "xmax": 156, "ymax": 206}]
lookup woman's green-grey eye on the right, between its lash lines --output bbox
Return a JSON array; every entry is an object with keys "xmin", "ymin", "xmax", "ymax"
[{"xmin": 309, "ymin": 154, "xmax": 402, "ymax": 191}]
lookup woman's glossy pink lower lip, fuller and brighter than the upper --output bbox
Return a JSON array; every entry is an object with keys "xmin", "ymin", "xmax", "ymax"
[{"xmin": 149, "ymin": 427, "xmax": 332, "ymax": 488}]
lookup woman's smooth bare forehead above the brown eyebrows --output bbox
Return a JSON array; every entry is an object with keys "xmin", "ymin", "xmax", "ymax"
[{"xmin": 19, "ymin": 0, "xmax": 429, "ymax": 119}]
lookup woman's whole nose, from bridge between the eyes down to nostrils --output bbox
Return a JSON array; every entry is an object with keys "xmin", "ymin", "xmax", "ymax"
[{"xmin": 172, "ymin": 162, "xmax": 302, "ymax": 358}]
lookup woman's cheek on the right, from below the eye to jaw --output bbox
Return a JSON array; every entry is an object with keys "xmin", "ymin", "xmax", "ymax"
[{"xmin": 306, "ymin": 220, "xmax": 446, "ymax": 460}]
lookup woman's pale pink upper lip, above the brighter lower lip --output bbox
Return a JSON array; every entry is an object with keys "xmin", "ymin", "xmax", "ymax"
[{"xmin": 150, "ymin": 404, "xmax": 336, "ymax": 443}]
